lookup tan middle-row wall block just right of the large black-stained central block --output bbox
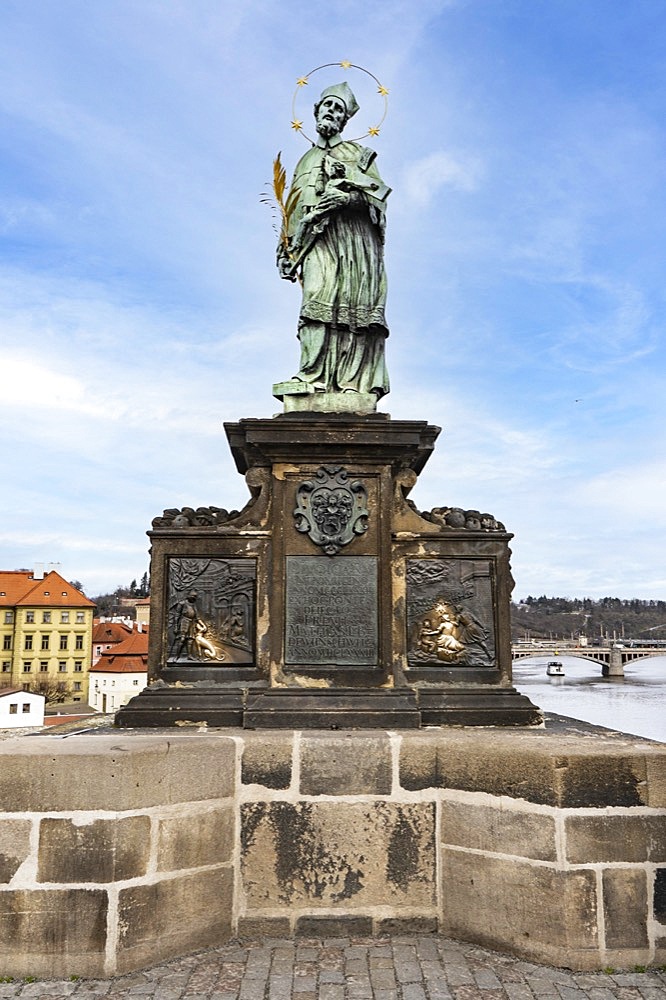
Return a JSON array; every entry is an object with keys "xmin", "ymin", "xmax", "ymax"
[{"xmin": 439, "ymin": 800, "xmax": 557, "ymax": 861}]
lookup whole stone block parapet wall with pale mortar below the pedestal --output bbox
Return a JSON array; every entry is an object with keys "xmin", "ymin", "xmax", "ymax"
[{"xmin": 0, "ymin": 730, "xmax": 666, "ymax": 977}]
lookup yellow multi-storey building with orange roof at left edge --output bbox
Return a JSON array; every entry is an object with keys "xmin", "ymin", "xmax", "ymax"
[{"xmin": 0, "ymin": 570, "xmax": 95, "ymax": 704}]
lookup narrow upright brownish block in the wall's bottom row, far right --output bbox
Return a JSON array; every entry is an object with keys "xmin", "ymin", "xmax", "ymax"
[{"xmin": 603, "ymin": 868, "xmax": 648, "ymax": 949}]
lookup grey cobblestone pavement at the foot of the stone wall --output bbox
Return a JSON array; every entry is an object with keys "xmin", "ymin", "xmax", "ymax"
[{"xmin": 0, "ymin": 936, "xmax": 666, "ymax": 1000}]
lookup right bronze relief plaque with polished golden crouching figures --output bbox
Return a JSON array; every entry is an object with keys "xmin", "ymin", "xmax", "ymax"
[{"xmin": 406, "ymin": 559, "xmax": 495, "ymax": 667}]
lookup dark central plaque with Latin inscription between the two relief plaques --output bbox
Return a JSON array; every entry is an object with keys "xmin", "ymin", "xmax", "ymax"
[{"xmin": 285, "ymin": 556, "xmax": 377, "ymax": 667}]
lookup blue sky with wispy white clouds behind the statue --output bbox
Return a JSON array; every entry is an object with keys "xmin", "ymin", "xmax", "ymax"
[{"xmin": 0, "ymin": 0, "xmax": 666, "ymax": 600}]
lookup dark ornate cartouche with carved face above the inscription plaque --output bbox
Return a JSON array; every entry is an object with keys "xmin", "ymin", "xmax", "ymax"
[{"xmin": 294, "ymin": 465, "xmax": 369, "ymax": 556}]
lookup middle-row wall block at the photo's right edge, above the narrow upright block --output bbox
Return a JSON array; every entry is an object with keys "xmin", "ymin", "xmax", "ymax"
[{"xmin": 565, "ymin": 814, "xmax": 666, "ymax": 864}]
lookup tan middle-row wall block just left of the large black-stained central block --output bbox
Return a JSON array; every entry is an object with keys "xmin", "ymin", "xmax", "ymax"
[{"xmin": 157, "ymin": 805, "xmax": 234, "ymax": 871}]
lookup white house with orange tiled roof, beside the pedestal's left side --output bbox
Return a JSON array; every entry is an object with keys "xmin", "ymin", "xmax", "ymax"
[{"xmin": 88, "ymin": 631, "xmax": 148, "ymax": 713}]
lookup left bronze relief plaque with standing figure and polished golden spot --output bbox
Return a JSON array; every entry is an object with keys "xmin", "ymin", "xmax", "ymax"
[{"xmin": 167, "ymin": 557, "xmax": 256, "ymax": 666}]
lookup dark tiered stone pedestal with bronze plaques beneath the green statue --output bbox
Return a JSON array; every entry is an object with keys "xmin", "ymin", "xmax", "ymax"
[{"xmin": 117, "ymin": 411, "xmax": 541, "ymax": 729}]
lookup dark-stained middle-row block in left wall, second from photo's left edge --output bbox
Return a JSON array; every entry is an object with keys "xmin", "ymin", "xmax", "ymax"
[{"xmin": 37, "ymin": 816, "xmax": 150, "ymax": 882}]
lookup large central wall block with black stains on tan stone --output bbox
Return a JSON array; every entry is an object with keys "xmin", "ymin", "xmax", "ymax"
[{"xmin": 241, "ymin": 802, "xmax": 435, "ymax": 916}]
